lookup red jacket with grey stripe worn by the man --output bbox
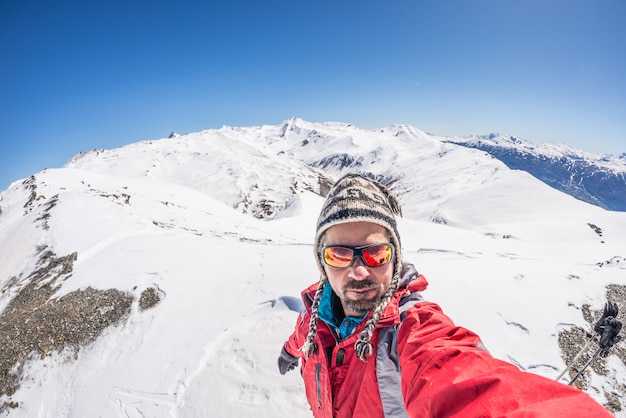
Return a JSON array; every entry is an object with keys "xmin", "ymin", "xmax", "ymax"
[{"xmin": 285, "ymin": 268, "xmax": 613, "ymax": 418}]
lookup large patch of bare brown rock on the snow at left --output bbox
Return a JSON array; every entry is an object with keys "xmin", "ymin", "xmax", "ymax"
[{"xmin": 0, "ymin": 251, "xmax": 134, "ymax": 412}]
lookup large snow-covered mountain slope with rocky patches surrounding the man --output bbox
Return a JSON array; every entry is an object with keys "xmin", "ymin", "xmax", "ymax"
[{"xmin": 0, "ymin": 118, "xmax": 626, "ymax": 417}]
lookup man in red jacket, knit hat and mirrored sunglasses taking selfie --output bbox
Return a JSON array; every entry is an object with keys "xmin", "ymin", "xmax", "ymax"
[{"xmin": 278, "ymin": 174, "xmax": 612, "ymax": 418}]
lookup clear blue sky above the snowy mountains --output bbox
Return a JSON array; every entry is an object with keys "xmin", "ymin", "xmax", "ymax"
[{"xmin": 0, "ymin": 0, "xmax": 626, "ymax": 190}]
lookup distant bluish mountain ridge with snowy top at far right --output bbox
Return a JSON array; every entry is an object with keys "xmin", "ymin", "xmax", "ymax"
[{"xmin": 449, "ymin": 134, "xmax": 626, "ymax": 212}]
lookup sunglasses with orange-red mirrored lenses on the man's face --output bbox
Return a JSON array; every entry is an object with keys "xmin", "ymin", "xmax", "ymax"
[{"xmin": 322, "ymin": 242, "xmax": 395, "ymax": 269}]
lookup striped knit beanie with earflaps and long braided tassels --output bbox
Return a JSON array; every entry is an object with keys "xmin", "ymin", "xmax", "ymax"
[{"xmin": 301, "ymin": 174, "xmax": 402, "ymax": 361}]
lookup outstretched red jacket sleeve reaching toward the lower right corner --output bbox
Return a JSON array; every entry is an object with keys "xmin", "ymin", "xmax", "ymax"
[{"xmin": 398, "ymin": 303, "xmax": 613, "ymax": 418}]
